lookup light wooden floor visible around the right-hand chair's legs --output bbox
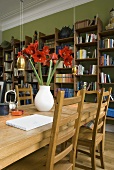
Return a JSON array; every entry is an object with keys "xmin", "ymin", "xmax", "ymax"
[{"xmin": 76, "ymin": 132, "xmax": 114, "ymax": 170}]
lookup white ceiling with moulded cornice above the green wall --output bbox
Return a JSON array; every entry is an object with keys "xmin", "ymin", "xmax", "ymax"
[{"xmin": 0, "ymin": 0, "xmax": 92, "ymax": 31}]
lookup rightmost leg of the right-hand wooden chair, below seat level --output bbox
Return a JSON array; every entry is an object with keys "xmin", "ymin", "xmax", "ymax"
[{"xmin": 99, "ymin": 140, "xmax": 105, "ymax": 169}]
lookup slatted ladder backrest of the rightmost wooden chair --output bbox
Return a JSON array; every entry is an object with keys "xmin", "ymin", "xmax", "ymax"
[{"xmin": 92, "ymin": 87, "xmax": 112, "ymax": 145}]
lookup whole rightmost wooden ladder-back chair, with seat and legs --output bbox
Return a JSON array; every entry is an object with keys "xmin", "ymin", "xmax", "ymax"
[{"xmin": 76, "ymin": 88, "xmax": 112, "ymax": 170}]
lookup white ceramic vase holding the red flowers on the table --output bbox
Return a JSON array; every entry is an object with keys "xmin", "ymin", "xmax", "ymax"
[{"xmin": 34, "ymin": 85, "xmax": 54, "ymax": 112}]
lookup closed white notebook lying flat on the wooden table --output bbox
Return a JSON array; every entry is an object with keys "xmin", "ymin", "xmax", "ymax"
[{"xmin": 6, "ymin": 114, "xmax": 53, "ymax": 131}]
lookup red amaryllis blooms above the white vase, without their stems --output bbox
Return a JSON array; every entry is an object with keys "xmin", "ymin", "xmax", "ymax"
[{"xmin": 18, "ymin": 41, "xmax": 73, "ymax": 66}]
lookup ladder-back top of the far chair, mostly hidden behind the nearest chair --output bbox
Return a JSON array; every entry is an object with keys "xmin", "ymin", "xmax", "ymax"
[{"xmin": 77, "ymin": 90, "xmax": 100, "ymax": 103}]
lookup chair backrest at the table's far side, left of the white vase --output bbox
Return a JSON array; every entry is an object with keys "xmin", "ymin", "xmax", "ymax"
[{"xmin": 15, "ymin": 84, "xmax": 33, "ymax": 106}]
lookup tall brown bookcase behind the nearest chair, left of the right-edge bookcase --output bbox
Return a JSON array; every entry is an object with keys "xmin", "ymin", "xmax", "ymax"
[{"xmin": 74, "ymin": 18, "xmax": 102, "ymax": 97}]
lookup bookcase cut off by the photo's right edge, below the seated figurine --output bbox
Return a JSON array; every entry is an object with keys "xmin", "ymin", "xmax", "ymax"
[{"xmin": 98, "ymin": 30, "xmax": 114, "ymax": 120}]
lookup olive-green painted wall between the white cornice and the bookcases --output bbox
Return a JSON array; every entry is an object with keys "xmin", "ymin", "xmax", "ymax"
[{"xmin": 2, "ymin": 0, "xmax": 114, "ymax": 41}]
